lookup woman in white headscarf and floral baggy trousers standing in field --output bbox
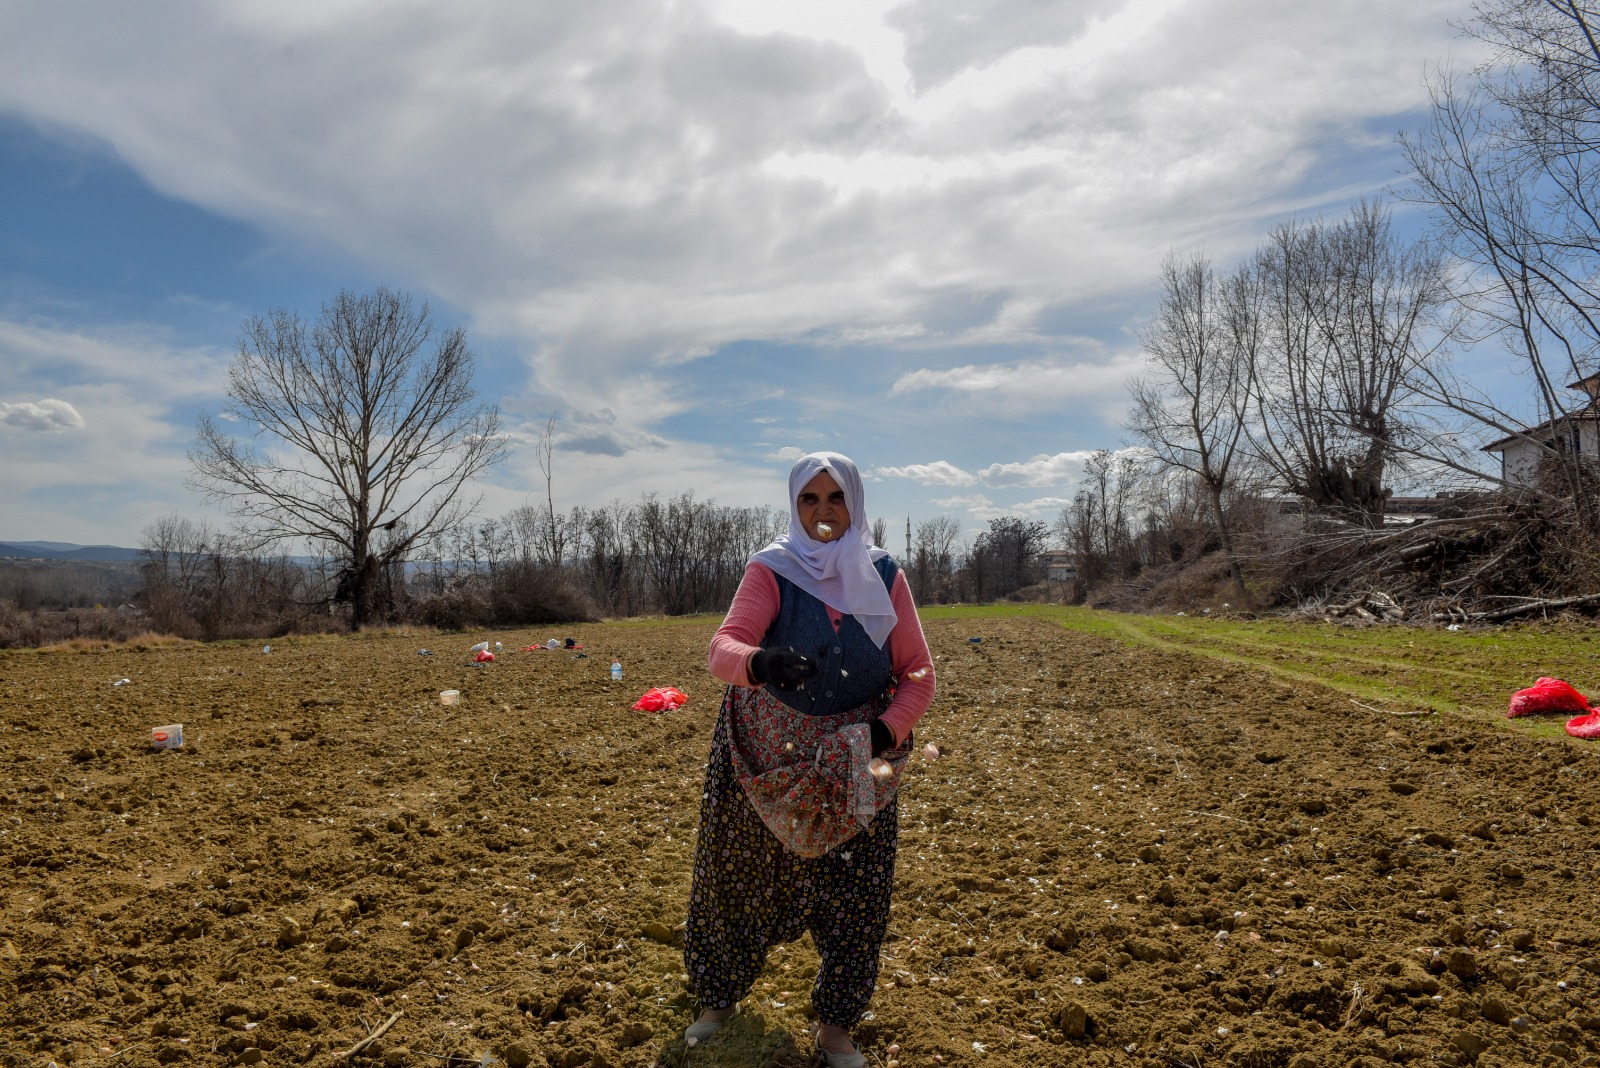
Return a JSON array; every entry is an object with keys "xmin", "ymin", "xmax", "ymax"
[{"xmin": 683, "ymin": 452, "xmax": 934, "ymax": 1068}]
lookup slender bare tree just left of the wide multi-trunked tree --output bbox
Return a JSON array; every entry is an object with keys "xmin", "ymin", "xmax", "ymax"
[{"xmin": 1128, "ymin": 256, "xmax": 1262, "ymax": 595}]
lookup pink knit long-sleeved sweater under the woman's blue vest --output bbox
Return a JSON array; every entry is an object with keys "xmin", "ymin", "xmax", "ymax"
[{"xmin": 706, "ymin": 563, "xmax": 934, "ymax": 742}]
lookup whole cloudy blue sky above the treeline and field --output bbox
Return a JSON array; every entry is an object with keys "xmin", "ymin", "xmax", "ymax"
[{"xmin": 0, "ymin": 0, "xmax": 1475, "ymax": 548}]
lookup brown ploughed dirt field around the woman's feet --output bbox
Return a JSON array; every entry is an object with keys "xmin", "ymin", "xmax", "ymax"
[{"xmin": 0, "ymin": 619, "xmax": 1600, "ymax": 1068}]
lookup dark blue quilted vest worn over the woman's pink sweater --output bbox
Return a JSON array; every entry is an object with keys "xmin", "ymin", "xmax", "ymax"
[{"xmin": 762, "ymin": 556, "xmax": 899, "ymax": 716}]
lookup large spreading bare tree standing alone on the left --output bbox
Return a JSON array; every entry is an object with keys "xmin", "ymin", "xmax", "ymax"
[{"xmin": 189, "ymin": 288, "xmax": 504, "ymax": 630}]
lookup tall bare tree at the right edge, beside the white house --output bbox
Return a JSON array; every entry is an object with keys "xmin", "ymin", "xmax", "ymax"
[{"xmin": 1402, "ymin": 0, "xmax": 1600, "ymax": 529}]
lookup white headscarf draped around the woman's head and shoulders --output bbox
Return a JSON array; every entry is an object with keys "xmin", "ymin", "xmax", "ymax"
[{"xmin": 750, "ymin": 452, "xmax": 896, "ymax": 649}]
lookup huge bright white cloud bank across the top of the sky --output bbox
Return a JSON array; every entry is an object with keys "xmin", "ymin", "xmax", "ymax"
[{"xmin": 0, "ymin": 0, "xmax": 1484, "ymax": 414}]
